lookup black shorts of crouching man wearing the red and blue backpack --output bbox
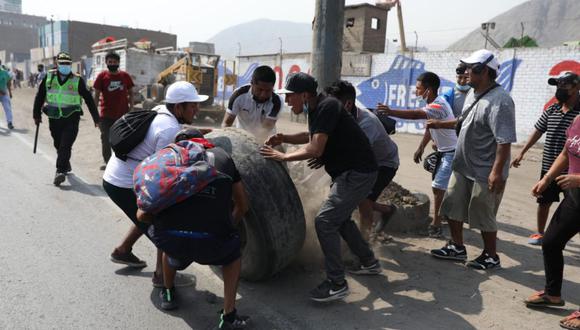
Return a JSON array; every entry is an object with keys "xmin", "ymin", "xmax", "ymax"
[{"xmin": 149, "ymin": 225, "xmax": 242, "ymax": 270}]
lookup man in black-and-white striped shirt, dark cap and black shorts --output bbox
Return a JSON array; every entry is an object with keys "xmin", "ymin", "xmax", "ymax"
[{"xmin": 511, "ymin": 72, "xmax": 580, "ymax": 245}]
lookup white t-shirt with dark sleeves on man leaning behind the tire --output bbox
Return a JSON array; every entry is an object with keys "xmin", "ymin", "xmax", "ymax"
[{"xmin": 227, "ymin": 85, "xmax": 282, "ymax": 135}]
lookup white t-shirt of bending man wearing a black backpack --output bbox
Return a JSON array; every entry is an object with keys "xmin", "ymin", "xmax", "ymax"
[{"xmin": 103, "ymin": 105, "xmax": 181, "ymax": 189}]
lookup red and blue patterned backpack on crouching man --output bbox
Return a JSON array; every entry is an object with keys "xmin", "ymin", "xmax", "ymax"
[{"xmin": 133, "ymin": 140, "xmax": 226, "ymax": 214}]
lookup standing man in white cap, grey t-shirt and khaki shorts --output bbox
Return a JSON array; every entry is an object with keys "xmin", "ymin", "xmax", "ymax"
[{"xmin": 431, "ymin": 49, "xmax": 516, "ymax": 270}]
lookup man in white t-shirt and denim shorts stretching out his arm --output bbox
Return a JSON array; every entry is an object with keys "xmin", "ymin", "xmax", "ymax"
[{"xmin": 377, "ymin": 72, "xmax": 457, "ymax": 238}]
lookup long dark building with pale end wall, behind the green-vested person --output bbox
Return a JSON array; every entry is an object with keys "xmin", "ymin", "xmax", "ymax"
[{"xmin": 31, "ymin": 21, "xmax": 177, "ymax": 62}]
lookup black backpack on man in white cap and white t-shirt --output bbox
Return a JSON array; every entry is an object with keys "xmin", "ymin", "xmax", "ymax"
[{"xmin": 109, "ymin": 110, "xmax": 157, "ymax": 161}]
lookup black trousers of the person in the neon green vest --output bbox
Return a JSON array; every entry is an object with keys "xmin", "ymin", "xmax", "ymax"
[{"xmin": 48, "ymin": 112, "xmax": 81, "ymax": 173}]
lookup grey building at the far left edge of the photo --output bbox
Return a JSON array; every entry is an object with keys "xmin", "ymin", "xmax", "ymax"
[{"xmin": 0, "ymin": 10, "xmax": 47, "ymax": 63}]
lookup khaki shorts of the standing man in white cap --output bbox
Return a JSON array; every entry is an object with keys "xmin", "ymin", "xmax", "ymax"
[{"xmin": 440, "ymin": 171, "xmax": 503, "ymax": 232}]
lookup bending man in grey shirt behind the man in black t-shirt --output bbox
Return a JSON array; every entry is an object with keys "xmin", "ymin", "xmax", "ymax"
[{"xmin": 322, "ymin": 80, "xmax": 399, "ymax": 240}]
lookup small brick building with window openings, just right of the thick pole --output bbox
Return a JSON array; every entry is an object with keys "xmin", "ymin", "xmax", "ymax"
[{"xmin": 343, "ymin": 3, "xmax": 388, "ymax": 53}]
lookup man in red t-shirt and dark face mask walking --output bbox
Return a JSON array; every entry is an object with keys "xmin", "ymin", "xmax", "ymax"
[{"xmin": 93, "ymin": 51, "xmax": 134, "ymax": 170}]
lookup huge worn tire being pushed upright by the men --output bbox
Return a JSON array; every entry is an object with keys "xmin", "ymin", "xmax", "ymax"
[{"xmin": 206, "ymin": 128, "xmax": 306, "ymax": 281}]
